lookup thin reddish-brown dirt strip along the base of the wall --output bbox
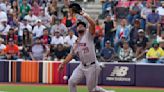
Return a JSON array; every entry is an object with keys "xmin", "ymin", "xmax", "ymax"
[{"xmin": 0, "ymin": 83, "xmax": 164, "ymax": 90}]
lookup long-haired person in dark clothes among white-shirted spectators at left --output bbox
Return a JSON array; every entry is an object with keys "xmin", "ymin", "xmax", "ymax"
[{"xmin": 22, "ymin": 28, "xmax": 33, "ymax": 47}]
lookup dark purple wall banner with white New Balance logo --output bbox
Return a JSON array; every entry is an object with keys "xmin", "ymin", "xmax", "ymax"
[{"xmin": 102, "ymin": 64, "xmax": 135, "ymax": 86}]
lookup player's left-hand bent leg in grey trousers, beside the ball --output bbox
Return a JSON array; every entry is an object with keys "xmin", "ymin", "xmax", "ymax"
[{"xmin": 68, "ymin": 65, "xmax": 84, "ymax": 92}]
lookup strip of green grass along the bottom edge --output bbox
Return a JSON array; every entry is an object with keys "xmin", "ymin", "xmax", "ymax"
[{"xmin": 0, "ymin": 85, "xmax": 164, "ymax": 92}]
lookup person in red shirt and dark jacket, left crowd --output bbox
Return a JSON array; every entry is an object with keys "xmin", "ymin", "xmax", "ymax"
[{"xmin": 40, "ymin": 28, "xmax": 51, "ymax": 44}]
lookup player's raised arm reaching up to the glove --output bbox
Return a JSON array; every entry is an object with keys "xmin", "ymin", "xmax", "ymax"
[{"xmin": 81, "ymin": 12, "xmax": 96, "ymax": 35}]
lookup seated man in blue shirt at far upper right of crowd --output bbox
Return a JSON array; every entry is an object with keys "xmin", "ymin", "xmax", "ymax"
[{"xmin": 146, "ymin": 8, "xmax": 160, "ymax": 38}]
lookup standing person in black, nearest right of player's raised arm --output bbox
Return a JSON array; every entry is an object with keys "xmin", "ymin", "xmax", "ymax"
[{"xmin": 104, "ymin": 15, "xmax": 115, "ymax": 45}]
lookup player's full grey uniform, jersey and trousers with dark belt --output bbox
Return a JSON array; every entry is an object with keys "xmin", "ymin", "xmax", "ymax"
[{"xmin": 68, "ymin": 31, "xmax": 105, "ymax": 92}]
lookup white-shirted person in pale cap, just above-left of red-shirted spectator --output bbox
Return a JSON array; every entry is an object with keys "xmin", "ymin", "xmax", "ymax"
[{"xmin": 32, "ymin": 20, "xmax": 46, "ymax": 38}]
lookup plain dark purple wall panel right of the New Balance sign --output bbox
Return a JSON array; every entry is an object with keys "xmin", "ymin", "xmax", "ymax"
[{"xmin": 136, "ymin": 64, "xmax": 164, "ymax": 87}]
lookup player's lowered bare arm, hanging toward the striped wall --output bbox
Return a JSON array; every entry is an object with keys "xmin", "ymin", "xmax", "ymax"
[{"xmin": 58, "ymin": 53, "xmax": 73, "ymax": 72}]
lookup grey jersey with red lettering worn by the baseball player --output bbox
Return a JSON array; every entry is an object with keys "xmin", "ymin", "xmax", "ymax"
[{"xmin": 71, "ymin": 31, "xmax": 97, "ymax": 64}]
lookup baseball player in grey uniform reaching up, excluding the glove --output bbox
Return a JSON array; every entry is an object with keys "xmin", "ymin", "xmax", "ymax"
[{"xmin": 58, "ymin": 4, "xmax": 114, "ymax": 92}]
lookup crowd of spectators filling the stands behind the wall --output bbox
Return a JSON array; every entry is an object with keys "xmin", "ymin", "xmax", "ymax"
[{"xmin": 0, "ymin": 0, "xmax": 164, "ymax": 63}]
